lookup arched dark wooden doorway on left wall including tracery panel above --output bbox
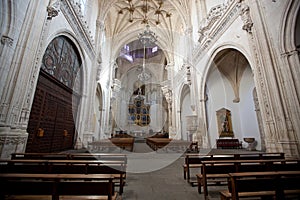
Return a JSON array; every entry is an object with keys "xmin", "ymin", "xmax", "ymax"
[{"xmin": 26, "ymin": 37, "xmax": 81, "ymax": 152}]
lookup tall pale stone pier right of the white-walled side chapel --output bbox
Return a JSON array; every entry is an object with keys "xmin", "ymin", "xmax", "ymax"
[{"xmin": 239, "ymin": 0, "xmax": 300, "ymax": 157}]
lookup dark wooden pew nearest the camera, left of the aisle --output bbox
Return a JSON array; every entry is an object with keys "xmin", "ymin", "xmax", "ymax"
[{"xmin": 0, "ymin": 173, "xmax": 118, "ymax": 200}]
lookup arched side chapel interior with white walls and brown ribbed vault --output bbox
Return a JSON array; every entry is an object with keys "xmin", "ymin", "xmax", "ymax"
[{"xmin": 205, "ymin": 48, "xmax": 260, "ymax": 149}]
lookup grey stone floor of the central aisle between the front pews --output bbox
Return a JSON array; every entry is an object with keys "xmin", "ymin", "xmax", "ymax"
[{"xmin": 118, "ymin": 143, "xmax": 249, "ymax": 200}]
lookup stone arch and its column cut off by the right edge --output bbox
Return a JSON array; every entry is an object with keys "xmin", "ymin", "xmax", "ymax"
[{"xmin": 278, "ymin": 1, "xmax": 300, "ymax": 156}]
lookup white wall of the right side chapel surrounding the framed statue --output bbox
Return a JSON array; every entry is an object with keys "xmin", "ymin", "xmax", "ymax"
[{"xmin": 207, "ymin": 64, "xmax": 261, "ymax": 149}]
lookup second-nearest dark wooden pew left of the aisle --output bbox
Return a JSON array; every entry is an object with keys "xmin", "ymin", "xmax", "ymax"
[{"xmin": 0, "ymin": 159, "xmax": 126, "ymax": 194}]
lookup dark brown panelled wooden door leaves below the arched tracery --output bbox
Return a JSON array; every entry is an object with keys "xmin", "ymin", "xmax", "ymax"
[{"xmin": 26, "ymin": 71, "xmax": 80, "ymax": 152}]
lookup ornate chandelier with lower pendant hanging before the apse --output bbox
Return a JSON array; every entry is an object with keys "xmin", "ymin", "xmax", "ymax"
[{"xmin": 138, "ymin": 24, "xmax": 157, "ymax": 82}]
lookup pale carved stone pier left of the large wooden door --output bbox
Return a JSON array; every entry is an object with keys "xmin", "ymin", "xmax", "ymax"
[{"xmin": 0, "ymin": 1, "xmax": 48, "ymax": 158}]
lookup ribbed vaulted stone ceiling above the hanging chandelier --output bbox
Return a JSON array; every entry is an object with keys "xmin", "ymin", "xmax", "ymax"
[{"xmin": 99, "ymin": 0, "xmax": 191, "ymax": 49}]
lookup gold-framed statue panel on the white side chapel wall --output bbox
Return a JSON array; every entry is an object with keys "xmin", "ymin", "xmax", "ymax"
[{"xmin": 217, "ymin": 108, "xmax": 234, "ymax": 137}]
